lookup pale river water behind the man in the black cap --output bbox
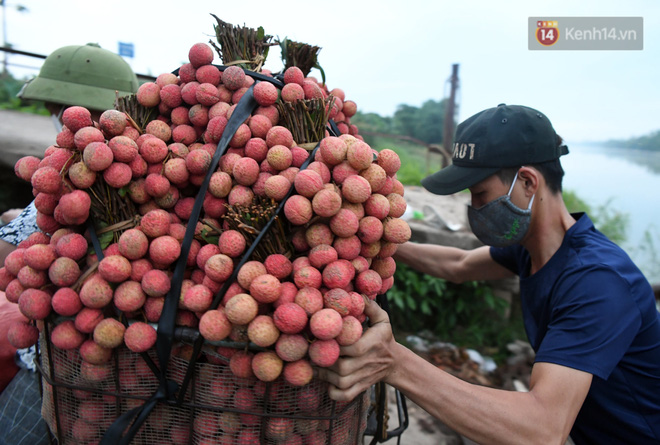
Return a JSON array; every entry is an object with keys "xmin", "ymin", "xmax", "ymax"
[{"xmin": 561, "ymin": 145, "xmax": 660, "ymax": 283}]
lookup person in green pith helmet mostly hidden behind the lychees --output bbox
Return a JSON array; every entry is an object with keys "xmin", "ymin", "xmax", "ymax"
[{"xmin": 0, "ymin": 43, "xmax": 139, "ymax": 445}]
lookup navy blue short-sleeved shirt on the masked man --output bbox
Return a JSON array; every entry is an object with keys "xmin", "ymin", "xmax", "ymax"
[{"xmin": 490, "ymin": 214, "xmax": 660, "ymax": 444}]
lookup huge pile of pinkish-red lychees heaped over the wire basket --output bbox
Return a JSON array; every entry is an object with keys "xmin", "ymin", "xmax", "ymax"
[{"xmin": 0, "ymin": 43, "xmax": 410, "ymax": 386}]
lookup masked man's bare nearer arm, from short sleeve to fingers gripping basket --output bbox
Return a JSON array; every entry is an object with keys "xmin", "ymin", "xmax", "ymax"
[{"xmin": 319, "ymin": 302, "xmax": 592, "ymax": 444}]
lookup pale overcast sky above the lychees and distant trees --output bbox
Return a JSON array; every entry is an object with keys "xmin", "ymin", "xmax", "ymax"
[{"xmin": 5, "ymin": 0, "xmax": 660, "ymax": 144}]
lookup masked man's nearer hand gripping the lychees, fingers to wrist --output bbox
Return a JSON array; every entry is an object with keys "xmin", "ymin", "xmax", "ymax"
[{"xmin": 318, "ymin": 300, "xmax": 396, "ymax": 401}]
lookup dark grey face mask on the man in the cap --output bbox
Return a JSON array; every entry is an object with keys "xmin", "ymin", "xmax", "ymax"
[{"xmin": 468, "ymin": 175, "xmax": 534, "ymax": 247}]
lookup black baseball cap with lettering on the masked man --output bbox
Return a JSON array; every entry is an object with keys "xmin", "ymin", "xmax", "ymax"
[{"xmin": 422, "ymin": 104, "xmax": 568, "ymax": 195}]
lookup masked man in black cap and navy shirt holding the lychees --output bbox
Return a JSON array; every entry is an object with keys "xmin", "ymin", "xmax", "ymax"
[{"xmin": 319, "ymin": 104, "xmax": 660, "ymax": 444}]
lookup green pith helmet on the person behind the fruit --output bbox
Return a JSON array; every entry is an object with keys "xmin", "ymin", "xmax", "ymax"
[{"xmin": 18, "ymin": 43, "xmax": 139, "ymax": 110}]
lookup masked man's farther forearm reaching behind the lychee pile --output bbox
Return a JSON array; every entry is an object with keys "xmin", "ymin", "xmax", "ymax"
[{"xmin": 394, "ymin": 242, "xmax": 513, "ymax": 283}]
